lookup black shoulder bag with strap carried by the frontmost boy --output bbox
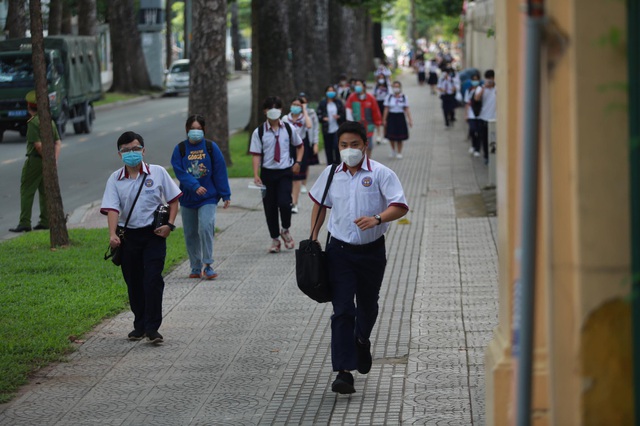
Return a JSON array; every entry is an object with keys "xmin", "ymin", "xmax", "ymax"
[{"xmin": 296, "ymin": 164, "xmax": 338, "ymax": 303}]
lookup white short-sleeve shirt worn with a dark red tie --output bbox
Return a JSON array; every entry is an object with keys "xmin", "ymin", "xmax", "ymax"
[{"xmin": 249, "ymin": 120, "xmax": 302, "ymax": 169}]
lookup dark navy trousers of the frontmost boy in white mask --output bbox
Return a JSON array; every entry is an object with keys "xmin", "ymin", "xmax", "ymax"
[{"xmin": 326, "ymin": 237, "xmax": 387, "ymax": 371}]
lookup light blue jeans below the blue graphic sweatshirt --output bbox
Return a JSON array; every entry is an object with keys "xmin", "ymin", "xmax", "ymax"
[{"xmin": 180, "ymin": 204, "xmax": 218, "ymax": 270}]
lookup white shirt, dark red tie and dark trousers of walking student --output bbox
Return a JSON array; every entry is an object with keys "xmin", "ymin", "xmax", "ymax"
[{"xmin": 249, "ymin": 120, "xmax": 302, "ymax": 239}]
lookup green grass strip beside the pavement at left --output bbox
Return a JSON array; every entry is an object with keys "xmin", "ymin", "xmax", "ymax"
[{"xmin": 0, "ymin": 229, "xmax": 186, "ymax": 403}]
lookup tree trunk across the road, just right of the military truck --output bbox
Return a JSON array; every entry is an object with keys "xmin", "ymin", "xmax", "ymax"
[{"xmin": 109, "ymin": 0, "xmax": 151, "ymax": 93}]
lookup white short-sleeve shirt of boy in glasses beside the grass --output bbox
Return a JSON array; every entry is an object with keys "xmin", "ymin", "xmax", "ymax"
[{"xmin": 100, "ymin": 163, "xmax": 182, "ymax": 229}]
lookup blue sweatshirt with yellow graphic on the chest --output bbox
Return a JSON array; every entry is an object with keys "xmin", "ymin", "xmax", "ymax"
[{"xmin": 171, "ymin": 138, "xmax": 231, "ymax": 209}]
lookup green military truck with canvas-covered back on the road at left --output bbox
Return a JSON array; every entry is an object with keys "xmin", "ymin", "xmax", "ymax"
[{"xmin": 0, "ymin": 36, "xmax": 102, "ymax": 141}]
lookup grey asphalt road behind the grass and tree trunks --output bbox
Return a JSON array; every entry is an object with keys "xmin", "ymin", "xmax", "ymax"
[{"xmin": 0, "ymin": 75, "xmax": 251, "ymax": 239}]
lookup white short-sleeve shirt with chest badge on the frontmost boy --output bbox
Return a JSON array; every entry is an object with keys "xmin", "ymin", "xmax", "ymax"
[{"xmin": 309, "ymin": 157, "xmax": 409, "ymax": 245}]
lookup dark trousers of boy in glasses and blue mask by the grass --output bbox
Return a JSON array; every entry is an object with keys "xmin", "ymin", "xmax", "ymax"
[{"xmin": 122, "ymin": 226, "xmax": 167, "ymax": 332}]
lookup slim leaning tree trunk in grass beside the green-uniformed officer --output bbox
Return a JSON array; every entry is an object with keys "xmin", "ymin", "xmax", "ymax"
[{"xmin": 29, "ymin": 0, "xmax": 69, "ymax": 248}]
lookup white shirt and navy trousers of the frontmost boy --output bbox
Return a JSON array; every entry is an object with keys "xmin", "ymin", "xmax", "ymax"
[{"xmin": 309, "ymin": 156, "xmax": 408, "ymax": 371}]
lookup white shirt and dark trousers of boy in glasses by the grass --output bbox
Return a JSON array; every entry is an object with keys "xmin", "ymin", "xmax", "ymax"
[{"xmin": 100, "ymin": 162, "xmax": 182, "ymax": 333}]
